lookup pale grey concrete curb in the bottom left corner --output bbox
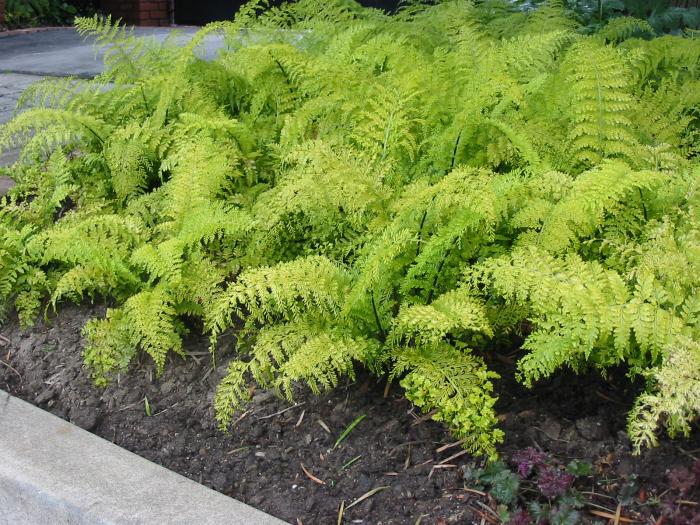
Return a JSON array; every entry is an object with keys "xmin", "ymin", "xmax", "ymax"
[{"xmin": 0, "ymin": 390, "xmax": 284, "ymax": 525}]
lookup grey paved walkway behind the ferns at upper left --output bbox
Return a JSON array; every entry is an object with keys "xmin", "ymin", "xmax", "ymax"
[{"xmin": 0, "ymin": 27, "xmax": 223, "ymax": 166}]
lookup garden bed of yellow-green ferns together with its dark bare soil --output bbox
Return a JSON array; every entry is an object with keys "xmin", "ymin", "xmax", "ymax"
[{"xmin": 0, "ymin": 0, "xmax": 700, "ymax": 525}]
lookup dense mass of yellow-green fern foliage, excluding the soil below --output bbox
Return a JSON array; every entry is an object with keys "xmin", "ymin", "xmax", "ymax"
[{"xmin": 0, "ymin": 0, "xmax": 700, "ymax": 456}]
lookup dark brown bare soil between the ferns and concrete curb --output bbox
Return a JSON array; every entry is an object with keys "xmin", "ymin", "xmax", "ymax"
[{"xmin": 0, "ymin": 307, "xmax": 700, "ymax": 525}]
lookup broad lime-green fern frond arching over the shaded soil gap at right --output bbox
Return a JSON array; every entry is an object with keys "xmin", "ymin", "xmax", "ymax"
[{"xmin": 472, "ymin": 248, "xmax": 687, "ymax": 385}]
